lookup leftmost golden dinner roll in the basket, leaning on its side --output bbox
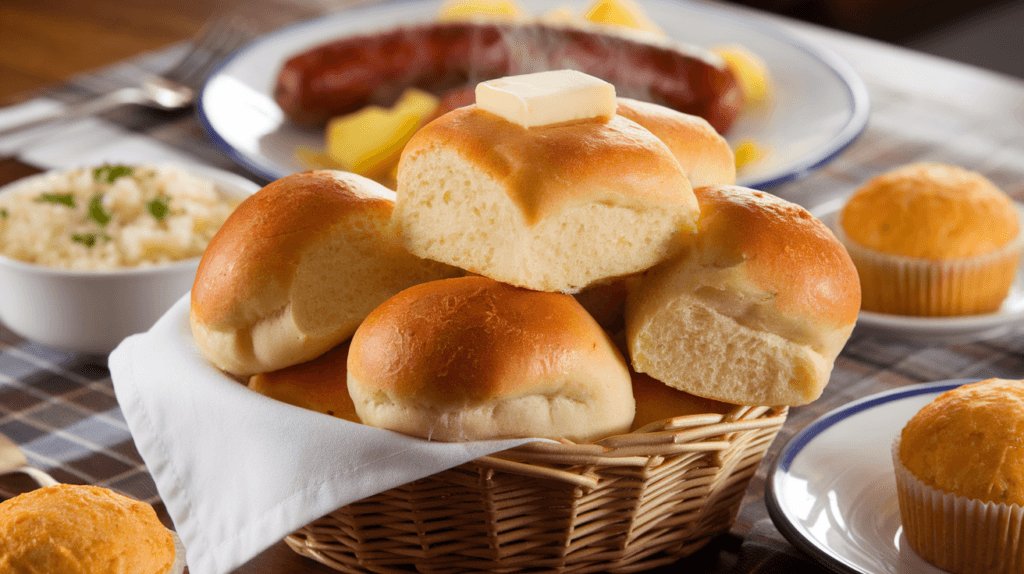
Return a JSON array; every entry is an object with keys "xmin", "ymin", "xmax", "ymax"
[{"xmin": 190, "ymin": 170, "xmax": 458, "ymax": 376}]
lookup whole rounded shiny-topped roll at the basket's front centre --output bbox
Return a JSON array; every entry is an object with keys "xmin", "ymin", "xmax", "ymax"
[{"xmin": 348, "ymin": 277, "xmax": 634, "ymax": 442}]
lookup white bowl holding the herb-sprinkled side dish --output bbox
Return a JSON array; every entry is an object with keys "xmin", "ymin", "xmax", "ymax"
[{"xmin": 0, "ymin": 166, "xmax": 260, "ymax": 353}]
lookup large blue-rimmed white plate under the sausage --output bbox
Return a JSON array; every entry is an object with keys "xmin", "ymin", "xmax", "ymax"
[{"xmin": 199, "ymin": 0, "xmax": 868, "ymax": 189}]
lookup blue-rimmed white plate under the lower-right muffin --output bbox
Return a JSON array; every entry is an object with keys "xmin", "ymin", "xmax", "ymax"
[{"xmin": 765, "ymin": 379, "xmax": 977, "ymax": 574}]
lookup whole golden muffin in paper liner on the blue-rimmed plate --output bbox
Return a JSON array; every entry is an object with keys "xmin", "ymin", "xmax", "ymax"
[{"xmin": 893, "ymin": 379, "xmax": 1024, "ymax": 574}]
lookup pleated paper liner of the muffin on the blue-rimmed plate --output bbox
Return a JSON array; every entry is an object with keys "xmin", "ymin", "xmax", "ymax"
[{"xmin": 892, "ymin": 437, "xmax": 1024, "ymax": 574}]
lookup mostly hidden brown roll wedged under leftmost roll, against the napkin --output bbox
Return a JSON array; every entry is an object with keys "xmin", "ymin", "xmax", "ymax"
[{"xmin": 249, "ymin": 342, "xmax": 359, "ymax": 423}]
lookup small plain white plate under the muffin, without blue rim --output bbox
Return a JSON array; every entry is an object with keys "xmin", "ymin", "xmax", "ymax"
[{"xmin": 809, "ymin": 197, "xmax": 1024, "ymax": 345}]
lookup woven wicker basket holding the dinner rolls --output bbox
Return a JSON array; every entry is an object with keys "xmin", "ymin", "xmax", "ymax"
[{"xmin": 286, "ymin": 406, "xmax": 786, "ymax": 574}]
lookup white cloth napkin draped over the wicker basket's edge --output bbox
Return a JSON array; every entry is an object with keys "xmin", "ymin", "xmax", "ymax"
[{"xmin": 110, "ymin": 296, "xmax": 536, "ymax": 574}]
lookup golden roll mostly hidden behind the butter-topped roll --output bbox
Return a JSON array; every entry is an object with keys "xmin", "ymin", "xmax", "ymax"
[{"xmin": 615, "ymin": 97, "xmax": 736, "ymax": 189}]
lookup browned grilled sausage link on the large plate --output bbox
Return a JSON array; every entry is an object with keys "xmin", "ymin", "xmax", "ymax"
[{"xmin": 274, "ymin": 23, "xmax": 743, "ymax": 133}]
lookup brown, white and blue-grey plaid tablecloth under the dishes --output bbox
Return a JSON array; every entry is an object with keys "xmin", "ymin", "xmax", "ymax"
[{"xmin": 0, "ymin": 2, "xmax": 1024, "ymax": 572}]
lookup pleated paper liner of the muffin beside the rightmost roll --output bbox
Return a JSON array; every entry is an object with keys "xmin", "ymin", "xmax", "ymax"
[{"xmin": 835, "ymin": 208, "xmax": 1024, "ymax": 316}]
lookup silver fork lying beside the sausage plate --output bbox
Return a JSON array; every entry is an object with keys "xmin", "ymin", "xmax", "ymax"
[{"xmin": 0, "ymin": 16, "xmax": 255, "ymax": 138}]
